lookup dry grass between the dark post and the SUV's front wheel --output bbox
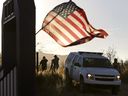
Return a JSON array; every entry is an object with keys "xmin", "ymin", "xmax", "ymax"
[{"xmin": 36, "ymin": 72, "xmax": 83, "ymax": 96}]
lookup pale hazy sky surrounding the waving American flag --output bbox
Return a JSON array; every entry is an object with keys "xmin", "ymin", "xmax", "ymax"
[{"xmin": 0, "ymin": 0, "xmax": 128, "ymax": 60}]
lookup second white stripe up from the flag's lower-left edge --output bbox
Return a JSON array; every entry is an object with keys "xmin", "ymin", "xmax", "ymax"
[{"xmin": 43, "ymin": 16, "xmax": 76, "ymax": 42}]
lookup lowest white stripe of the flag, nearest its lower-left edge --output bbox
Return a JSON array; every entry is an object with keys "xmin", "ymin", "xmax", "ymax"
[{"xmin": 45, "ymin": 24, "xmax": 69, "ymax": 45}]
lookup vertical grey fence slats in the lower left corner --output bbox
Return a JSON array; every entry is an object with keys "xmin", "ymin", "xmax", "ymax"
[{"xmin": 0, "ymin": 66, "xmax": 16, "ymax": 96}]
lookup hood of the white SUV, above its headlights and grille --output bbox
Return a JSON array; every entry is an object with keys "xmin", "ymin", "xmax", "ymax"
[{"xmin": 83, "ymin": 67, "xmax": 119, "ymax": 75}]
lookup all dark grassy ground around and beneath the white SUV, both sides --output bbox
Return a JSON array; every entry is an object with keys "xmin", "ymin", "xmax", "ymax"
[{"xmin": 36, "ymin": 66, "xmax": 128, "ymax": 96}]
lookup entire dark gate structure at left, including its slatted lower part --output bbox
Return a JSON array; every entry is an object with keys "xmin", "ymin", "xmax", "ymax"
[{"xmin": 0, "ymin": 0, "xmax": 36, "ymax": 96}]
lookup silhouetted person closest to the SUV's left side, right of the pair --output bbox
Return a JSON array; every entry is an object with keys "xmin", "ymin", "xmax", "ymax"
[{"xmin": 49, "ymin": 55, "xmax": 59, "ymax": 72}]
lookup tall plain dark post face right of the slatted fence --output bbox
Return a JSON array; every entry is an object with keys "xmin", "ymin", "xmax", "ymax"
[{"xmin": 14, "ymin": 0, "xmax": 35, "ymax": 96}]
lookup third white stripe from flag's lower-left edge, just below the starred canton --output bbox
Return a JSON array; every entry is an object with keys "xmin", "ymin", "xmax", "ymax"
[{"xmin": 51, "ymin": 12, "xmax": 84, "ymax": 38}]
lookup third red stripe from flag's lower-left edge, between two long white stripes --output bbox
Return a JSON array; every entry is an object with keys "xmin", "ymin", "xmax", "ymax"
[{"xmin": 50, "ymin": 15, "xmax": 80, "ymax": 40}]
